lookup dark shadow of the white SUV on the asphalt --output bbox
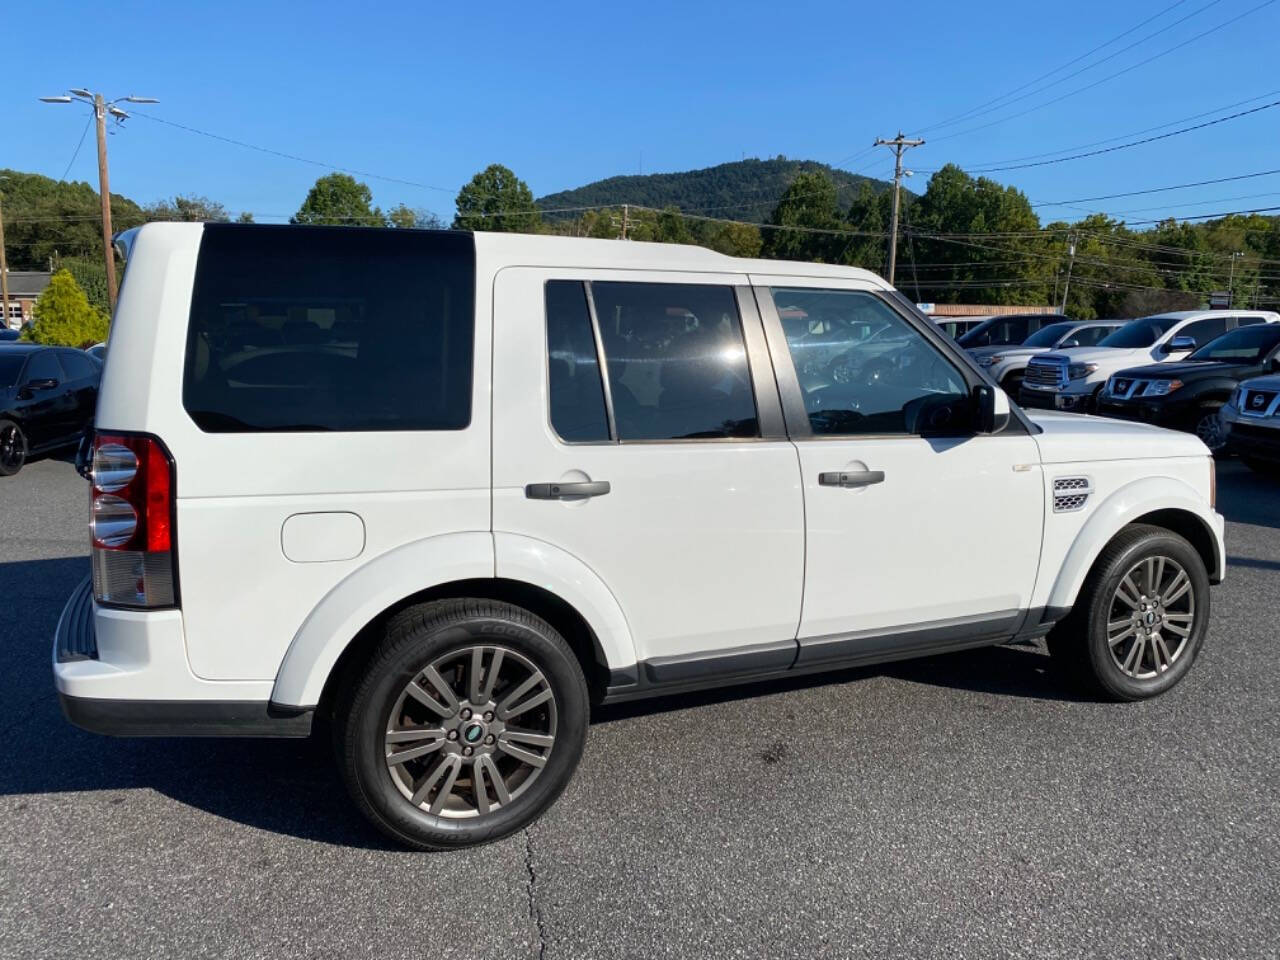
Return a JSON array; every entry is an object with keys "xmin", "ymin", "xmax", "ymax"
[{"xmin": 0, "ymin": 556, "xmax": 1090, "ymax": 850}]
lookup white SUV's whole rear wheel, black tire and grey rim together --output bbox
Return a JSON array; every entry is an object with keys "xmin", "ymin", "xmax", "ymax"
[{"xmin": 334, "ymin": 600, "xmax": 589, "ymax": 850}]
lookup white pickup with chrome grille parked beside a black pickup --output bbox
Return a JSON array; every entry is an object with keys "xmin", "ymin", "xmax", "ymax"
[{"xmin": 1019, "ymin": 310, "xmax": 1280, "ymax": 413}]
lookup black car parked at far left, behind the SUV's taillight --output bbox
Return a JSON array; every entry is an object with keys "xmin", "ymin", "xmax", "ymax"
[{"xmin": 0, "ymin": 343, "xmax": 102, "ymax": 476}]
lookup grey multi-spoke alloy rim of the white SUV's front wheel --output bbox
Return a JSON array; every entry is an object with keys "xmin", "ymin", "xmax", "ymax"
[{"xmin": 1107, "ymin": 556, "xmax": 1196, "ymax": 680}]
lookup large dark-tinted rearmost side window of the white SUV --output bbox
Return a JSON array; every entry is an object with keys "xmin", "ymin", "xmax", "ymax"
[{"xmin": 183, "ymin": 225, "xmax": 475, "ymax": 433}]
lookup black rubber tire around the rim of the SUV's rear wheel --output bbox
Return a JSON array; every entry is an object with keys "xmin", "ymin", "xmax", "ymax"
[{"xmin": 333, "ymin": 599, "xmax": 590, "ymax": 850}]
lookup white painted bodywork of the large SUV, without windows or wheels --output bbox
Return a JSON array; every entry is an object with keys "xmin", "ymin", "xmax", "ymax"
[{"xmin": 55, "ymin": 224, "xmax": 1225, "ymax": 707}]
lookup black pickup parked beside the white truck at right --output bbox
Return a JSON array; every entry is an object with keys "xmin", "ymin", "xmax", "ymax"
[{"xmin": 1098, "ymin": 324, "xmax": 1280, "ymax": 453}]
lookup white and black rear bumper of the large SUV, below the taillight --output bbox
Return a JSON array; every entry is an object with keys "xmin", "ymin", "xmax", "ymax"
[{"xmin": 54, "ymin": 579, "xmax": 312, "ymax": 737}]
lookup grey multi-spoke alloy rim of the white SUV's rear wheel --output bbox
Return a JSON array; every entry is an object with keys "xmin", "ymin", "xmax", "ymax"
[{"xmin": 384, "ymin": 644, "xmax": 557, "ymax": 819}]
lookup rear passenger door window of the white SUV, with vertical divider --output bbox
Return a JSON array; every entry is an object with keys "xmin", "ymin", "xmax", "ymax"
[{"xmin": 547, "ymin": 280, "xmax": 760, "ymax": 443}]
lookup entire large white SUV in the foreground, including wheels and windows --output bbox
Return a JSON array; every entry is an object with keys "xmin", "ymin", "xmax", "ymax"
[{"xmin": 54, "ymin": 224, "xmax": 1225, "ymax": 847}]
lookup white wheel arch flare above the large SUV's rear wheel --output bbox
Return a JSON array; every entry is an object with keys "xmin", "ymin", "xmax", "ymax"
[{"xmin": 271, "ymin": 532, "xmax": 635, "ymax": 712}]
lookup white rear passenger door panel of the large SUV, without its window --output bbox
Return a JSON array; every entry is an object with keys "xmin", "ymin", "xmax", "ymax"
[{"xmin": 493, "ymin": 269, "xmax": 804, "ymax": 659}]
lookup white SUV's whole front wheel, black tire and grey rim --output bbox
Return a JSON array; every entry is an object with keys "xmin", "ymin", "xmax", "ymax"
[{"xmin": 1048, "ymin": 524, "xmax": 1210, "ymax": 700}]
